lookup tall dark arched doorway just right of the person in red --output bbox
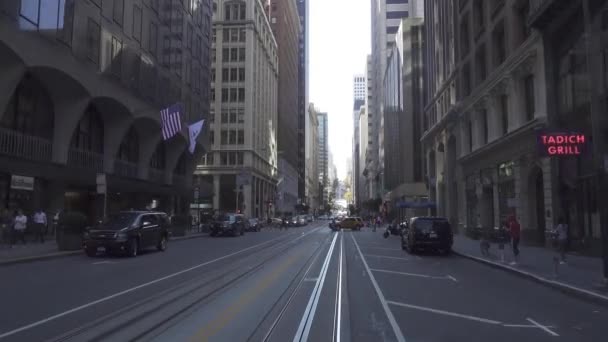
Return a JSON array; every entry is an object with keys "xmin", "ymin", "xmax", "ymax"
[{"xmin": 526, "ymin": 164, "xmax": 547, "ymax": 244}]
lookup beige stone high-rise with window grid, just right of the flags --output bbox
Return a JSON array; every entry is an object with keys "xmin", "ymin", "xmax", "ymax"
[{"xmin": 197, "ymin": 0, "xmax": 278, "ymax": 217}]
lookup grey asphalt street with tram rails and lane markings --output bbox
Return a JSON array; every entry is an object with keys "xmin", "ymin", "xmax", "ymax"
[{"xmin": 0, "ymin": 222, "xmax": 608, "ymax": 342}]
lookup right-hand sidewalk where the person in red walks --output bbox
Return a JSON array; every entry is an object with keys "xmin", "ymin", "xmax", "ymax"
[{"xmin": 453, "ymin": 235, "xmax": 608, "ymax": 303}]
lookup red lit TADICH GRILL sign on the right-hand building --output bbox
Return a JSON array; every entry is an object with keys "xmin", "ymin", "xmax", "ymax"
[{"xmin": 536, "ymin": 131, "xmax": 589, "ymax": 157}]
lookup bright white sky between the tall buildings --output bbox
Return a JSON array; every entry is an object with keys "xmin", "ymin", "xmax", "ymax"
[{"xmin": 309, "ymin": 0, "xmax": 371, "ymax": 179}]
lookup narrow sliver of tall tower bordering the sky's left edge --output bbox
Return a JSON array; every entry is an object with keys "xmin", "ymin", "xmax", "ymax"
[{"xmin": 297, "ymin": 0, "xmax": 310, "ymax": 200}]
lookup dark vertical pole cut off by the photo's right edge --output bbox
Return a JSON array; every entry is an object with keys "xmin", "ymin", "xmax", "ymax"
[{"xmin": 583, "ymin": 0, "xmax": 608, "ymax": 282}]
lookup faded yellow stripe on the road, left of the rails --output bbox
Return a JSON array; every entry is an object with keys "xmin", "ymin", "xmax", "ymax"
[{"xmin": 190, "ymin": 252, "xmax": 302, "ymax": 342}]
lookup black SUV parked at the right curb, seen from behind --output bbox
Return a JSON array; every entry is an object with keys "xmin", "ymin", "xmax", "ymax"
[{"xmin": 401, "ymin": 217, "xmax": 454, "ymax": 254}]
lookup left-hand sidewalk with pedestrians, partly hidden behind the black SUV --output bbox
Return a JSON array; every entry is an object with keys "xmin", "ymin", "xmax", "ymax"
[{"xmin": 0, "ymin": 231, "xmax": 208, "ymax": 266}]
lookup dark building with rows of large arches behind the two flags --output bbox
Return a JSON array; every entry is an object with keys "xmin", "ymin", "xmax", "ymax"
[{"xmin": 0, "ymin": 0, "xmax": 211, "ymax": 220}]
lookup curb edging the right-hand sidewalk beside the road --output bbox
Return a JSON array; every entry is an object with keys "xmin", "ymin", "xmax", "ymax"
[{"xmin": 452, "ymin": 250, "xmax": 608, "ymax": 307}]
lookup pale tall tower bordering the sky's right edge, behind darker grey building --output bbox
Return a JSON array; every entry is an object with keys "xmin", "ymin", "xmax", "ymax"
[{"xmin": 368, "ymin": 0, "xmax": 424, "ymax": 197}]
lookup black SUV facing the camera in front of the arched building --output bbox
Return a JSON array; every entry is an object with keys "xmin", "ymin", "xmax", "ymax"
[{"xmin": 83, "ymin": 211, "xmax": 170, "ymax": 257}]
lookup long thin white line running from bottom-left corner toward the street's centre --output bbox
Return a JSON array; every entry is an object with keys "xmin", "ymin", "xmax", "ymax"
[{"xmin": 0, "ymin": 228, "xmax": 320, "ymax": 339}]
